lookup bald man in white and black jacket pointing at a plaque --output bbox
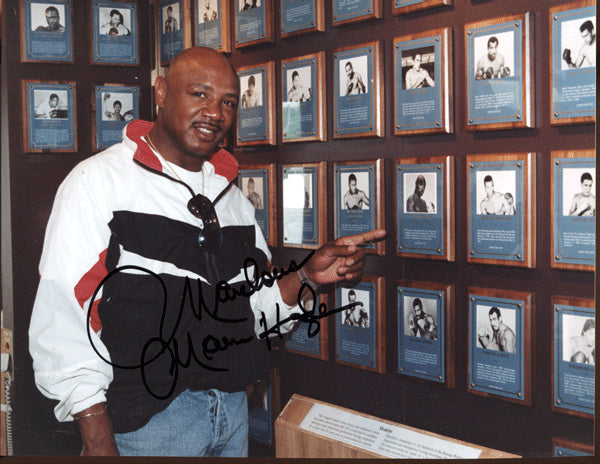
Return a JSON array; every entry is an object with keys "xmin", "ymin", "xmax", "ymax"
[{"xmin": 29, "ymin": 48, "xmax": 385, "ymax": 456}]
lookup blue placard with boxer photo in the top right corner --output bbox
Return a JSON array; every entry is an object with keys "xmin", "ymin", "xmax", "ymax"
[{"xmin": 551, "ymin": 6, "xmax": 596, "ymax": 121}]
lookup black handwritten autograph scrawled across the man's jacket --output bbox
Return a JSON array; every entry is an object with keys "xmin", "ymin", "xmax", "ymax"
[{"xmin": 86, "ymin": 252, "xmax": 357, "ymax": 399}]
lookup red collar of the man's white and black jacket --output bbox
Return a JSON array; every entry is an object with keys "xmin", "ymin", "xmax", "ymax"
[{"xmin": 125, "ymin": 119, "xmax": 238, "ymax": 182}]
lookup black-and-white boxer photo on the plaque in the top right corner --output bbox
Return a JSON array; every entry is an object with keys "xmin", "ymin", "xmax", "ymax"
[{"xmin": 560, "ymin": 16, "xmax": 596, "ymax": 71}]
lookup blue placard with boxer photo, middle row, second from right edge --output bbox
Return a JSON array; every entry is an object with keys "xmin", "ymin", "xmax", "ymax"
[{"xmin": 469, "ymin": 159, "xmax": 526, "ymax": 261}]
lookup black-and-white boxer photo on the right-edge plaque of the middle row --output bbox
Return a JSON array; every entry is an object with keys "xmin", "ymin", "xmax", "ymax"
[{"xmin": 562, "ymin": 168, "xmax": 596, "ymax": 217}]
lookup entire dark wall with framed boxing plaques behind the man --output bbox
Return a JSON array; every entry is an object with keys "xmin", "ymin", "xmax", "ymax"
[{"xmin": 2, "ymin": 0, "xmax": 596, "ymax": 457}]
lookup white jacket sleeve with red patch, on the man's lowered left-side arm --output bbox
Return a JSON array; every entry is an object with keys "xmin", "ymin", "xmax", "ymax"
[{"xmin": 29, "ymin": 162, "xmax": 112, "ymax": 421}]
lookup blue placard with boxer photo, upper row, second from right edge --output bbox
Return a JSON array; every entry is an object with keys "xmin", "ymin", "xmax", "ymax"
[{"xmin": 467, "ymin": 20, "xmax": 526, "ymax": 125}]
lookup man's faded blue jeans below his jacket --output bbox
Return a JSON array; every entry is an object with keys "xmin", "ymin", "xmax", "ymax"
[{"xmin": 115, "ymin": 390, "xmax": 248, "ymax": 457}]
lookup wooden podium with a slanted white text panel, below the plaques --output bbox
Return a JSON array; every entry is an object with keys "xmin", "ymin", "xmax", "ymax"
[{"xmin": 275, "ymin": 395, "xmax": 520, "ymax": 459}]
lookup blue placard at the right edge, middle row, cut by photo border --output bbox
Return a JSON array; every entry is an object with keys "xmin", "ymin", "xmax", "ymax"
[{"xmin": 552, "ymin": 158, "xmax": 596, "ymax": 266}]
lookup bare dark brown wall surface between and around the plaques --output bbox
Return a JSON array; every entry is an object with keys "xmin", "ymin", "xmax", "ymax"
[{"xmin": 2, "ymin": 0, "xmax": 594, "ymax": 456}]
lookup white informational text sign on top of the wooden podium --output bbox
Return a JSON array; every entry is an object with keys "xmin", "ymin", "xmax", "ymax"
[{"xmin": 300, "ymin": 404, "xmax": 481, "ymax": 459}]
